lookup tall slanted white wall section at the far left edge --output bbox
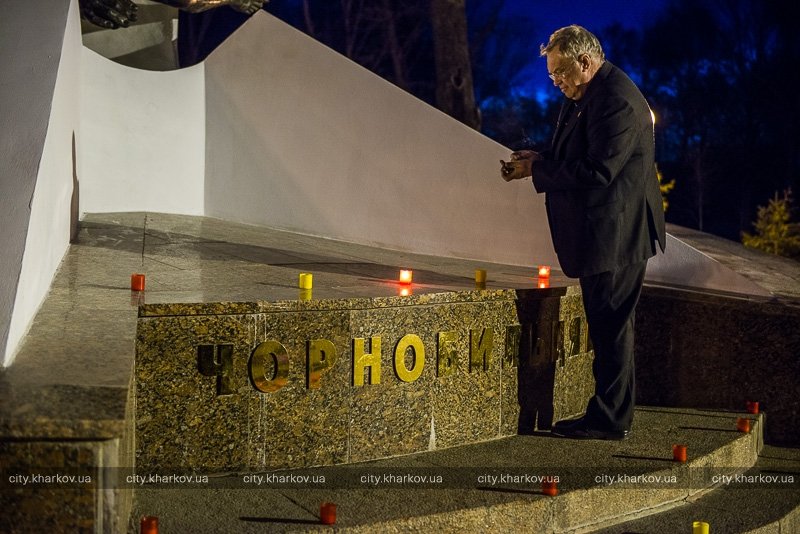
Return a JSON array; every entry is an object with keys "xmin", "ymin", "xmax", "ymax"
[{"xmin": 0, "ymin": 0, "xmax": 80, "ymax": 366}]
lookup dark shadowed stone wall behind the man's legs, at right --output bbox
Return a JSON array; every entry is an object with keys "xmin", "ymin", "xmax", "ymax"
[{"xmin": 636, "ymin": 288, "xmax": 800, "ymax": 446}]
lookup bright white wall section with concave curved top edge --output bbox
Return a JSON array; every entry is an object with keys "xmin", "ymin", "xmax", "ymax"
[{"xmin": 78, "ymin": 48, "xmax": 205, "ymax": 215}]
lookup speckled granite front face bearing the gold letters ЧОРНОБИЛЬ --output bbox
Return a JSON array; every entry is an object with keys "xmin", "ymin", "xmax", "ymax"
[{"xmin": 136, "ymin": 288, "xmax": 580, "ymax": 470}]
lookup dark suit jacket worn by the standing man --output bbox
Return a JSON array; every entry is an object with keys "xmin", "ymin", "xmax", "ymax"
[{"xmin": 532, "ymin": 61, "xmax": 666, "ymax": 278}]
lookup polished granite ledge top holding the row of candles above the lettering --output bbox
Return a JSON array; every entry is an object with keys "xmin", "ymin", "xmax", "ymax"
[{"xmin": 0, "ymin": 213, "xmax": 568, "ymax": 531}]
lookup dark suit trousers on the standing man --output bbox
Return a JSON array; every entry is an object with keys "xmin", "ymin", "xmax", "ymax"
[{"xmin": 580, "ymin": 260, "xmax": 647, "ymax": 431}]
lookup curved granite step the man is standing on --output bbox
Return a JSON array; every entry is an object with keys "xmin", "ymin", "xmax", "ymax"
[{"xmin": 130, "ymin": 407, "xmax": 776, "ymax": 533}]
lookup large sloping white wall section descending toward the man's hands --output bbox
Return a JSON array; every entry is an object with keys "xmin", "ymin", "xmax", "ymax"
[{"xmin": 205, "ymin": 12, "xmax": 557, "ymax": 265}]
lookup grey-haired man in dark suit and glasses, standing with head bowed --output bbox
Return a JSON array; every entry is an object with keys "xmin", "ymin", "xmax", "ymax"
[{"xmin": 501, "ymin": 26, "xmax": 666, "ymax": 439}]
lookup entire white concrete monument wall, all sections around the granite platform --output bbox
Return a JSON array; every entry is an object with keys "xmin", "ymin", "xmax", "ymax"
[{"xmin": 0, "ymin": 6, "xmax": 766, "ymax": 365}]
